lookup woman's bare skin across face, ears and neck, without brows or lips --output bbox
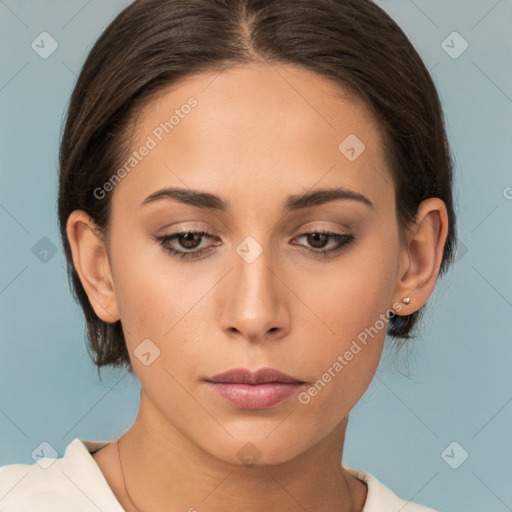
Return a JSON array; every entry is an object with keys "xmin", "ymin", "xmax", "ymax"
[{"xmin": 67, "ymin": 63, "xmax": 448, "ymax": 512}]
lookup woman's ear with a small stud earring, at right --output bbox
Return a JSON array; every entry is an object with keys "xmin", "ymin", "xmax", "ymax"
[{"xmin": 394, "ymin": 197, "xmax": 448, "ymax": 315}]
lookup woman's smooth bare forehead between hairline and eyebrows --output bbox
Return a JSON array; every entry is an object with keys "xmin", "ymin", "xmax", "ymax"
[{"xmin": 115, "ymin": 63, "xmax": 393, "ymax": 214}]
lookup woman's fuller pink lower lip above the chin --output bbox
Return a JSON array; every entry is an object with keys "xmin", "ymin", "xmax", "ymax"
[{"xmin": 206, "ymin": 381, "xmax": 302, "ymax": 409}]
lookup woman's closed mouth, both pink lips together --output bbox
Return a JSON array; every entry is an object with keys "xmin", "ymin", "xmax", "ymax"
[{"xmin": 203, "ymin": 368, "xmax": 306, "ymax": 409}]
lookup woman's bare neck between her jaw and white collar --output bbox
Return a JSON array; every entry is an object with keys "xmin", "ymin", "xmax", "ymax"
[{"xmin": 116, "ymin": 392, "xmax": 366, "ymax": 512}]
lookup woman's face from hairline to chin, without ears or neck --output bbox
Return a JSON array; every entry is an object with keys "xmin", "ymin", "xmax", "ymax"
[{"xmin": 91, "ymin": 64, "xmax": 403, "ymax": 463}]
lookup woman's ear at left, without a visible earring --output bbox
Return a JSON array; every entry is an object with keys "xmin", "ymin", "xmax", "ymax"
[{"xmin": 66, "ymin": 210, "xmax": 120, "ymax": 322}]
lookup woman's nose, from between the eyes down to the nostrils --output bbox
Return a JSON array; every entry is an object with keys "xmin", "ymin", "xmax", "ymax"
[{"xmin": 221, "ymin": 238, "xmax": 290, "ymax": 343}]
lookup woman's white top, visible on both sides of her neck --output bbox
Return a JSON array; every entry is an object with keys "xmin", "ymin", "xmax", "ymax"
[{"xmin": 0, "ymin": 438, "xmax": 436, "ymax": 512}]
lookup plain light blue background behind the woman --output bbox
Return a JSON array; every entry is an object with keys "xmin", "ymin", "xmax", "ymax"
[{"xmin": 0, "ymin": 0, "xmax": 512, "ymax": 512}]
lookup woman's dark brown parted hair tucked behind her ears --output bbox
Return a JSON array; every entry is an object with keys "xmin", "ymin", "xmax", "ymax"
[{"xmin": 58, "ymin": 0, "xmax": 456, "ymax": 373}]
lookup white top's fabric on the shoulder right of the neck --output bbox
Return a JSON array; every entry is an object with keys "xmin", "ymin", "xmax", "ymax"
[{"xmin": 344, "ymin": 466, "xmax": 438, "ymax": 512}]
